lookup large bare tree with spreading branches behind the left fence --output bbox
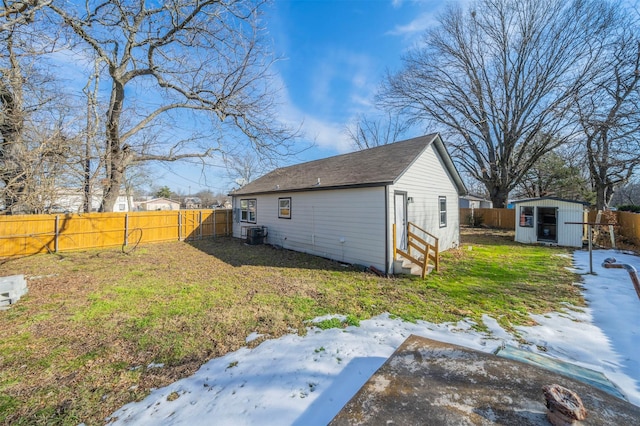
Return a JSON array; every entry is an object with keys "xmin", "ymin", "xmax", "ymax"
[{"xmin": 50, "ymin": 0, "xmax": 293, "ymax": 211}]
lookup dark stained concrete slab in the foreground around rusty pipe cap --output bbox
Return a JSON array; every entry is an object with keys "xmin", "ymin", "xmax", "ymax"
[{"xmin": 330, "ymin": 336, "xmax": 640, "ymax": 426}]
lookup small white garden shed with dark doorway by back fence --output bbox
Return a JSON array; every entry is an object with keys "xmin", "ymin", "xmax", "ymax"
[{"xmin": 514, "ymin": 197, "xmax": 588, "ymax": 247}]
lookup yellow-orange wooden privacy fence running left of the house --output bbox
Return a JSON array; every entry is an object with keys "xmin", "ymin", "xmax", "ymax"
[{"xmin": 0, "ymin": 209, "xmax": 232, "ymax": 257}]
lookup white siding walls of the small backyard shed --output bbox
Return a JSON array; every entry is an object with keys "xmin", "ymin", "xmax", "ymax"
[{"xmin": 515, "ymin": 198, "xmax": 585, "ymax": 247}]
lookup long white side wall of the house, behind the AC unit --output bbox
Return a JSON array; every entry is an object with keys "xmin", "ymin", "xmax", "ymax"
[{"xmin": 233, "ymin": 187, "xmax": 386, "ymax": 270}]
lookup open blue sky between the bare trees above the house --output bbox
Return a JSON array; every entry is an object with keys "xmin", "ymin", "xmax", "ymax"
[{"xmin": 155, "ymin": 0, "xmax": 446, "ymax": 194}]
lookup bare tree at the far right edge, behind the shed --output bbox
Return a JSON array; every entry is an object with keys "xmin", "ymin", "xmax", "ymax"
[{"xmin": 574, "ymin": 14, "xmax": 640, "ymax": 210}]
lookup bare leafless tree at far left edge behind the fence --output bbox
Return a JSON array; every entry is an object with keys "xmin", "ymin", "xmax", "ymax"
[{"xmin": 0, "ymin": 0, "xmax": 77, "ymax": 213}]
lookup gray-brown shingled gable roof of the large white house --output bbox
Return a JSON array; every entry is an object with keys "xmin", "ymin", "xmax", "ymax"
[{"xmin": 232, "ymin": 133, "xmax": 466, "ymax": 195}]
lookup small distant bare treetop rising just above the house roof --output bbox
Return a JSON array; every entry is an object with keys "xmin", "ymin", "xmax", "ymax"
[{"xmin": 345, "ymin": 113, "xmax": 410, "ymax": 150}]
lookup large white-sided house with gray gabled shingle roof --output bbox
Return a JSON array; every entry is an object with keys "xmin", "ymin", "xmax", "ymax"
[{"xmin": 231, "ymin": 134, "xmax": 466, "ymax": 273}]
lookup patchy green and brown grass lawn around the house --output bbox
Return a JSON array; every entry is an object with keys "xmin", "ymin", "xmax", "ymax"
[{"xmin": 0, "ymin": 230, "xmax": 583, "ymax": 425}]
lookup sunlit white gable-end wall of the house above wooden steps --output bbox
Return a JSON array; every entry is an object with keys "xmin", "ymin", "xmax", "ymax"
[{"xmin": 387, "ymin": 145, "xmax": 460, "ymax": 250}]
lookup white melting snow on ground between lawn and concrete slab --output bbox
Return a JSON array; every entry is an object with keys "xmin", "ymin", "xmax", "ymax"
[{"xmin": 109, "ymin": 250, "xmax": 640, "ymax": 426}]
